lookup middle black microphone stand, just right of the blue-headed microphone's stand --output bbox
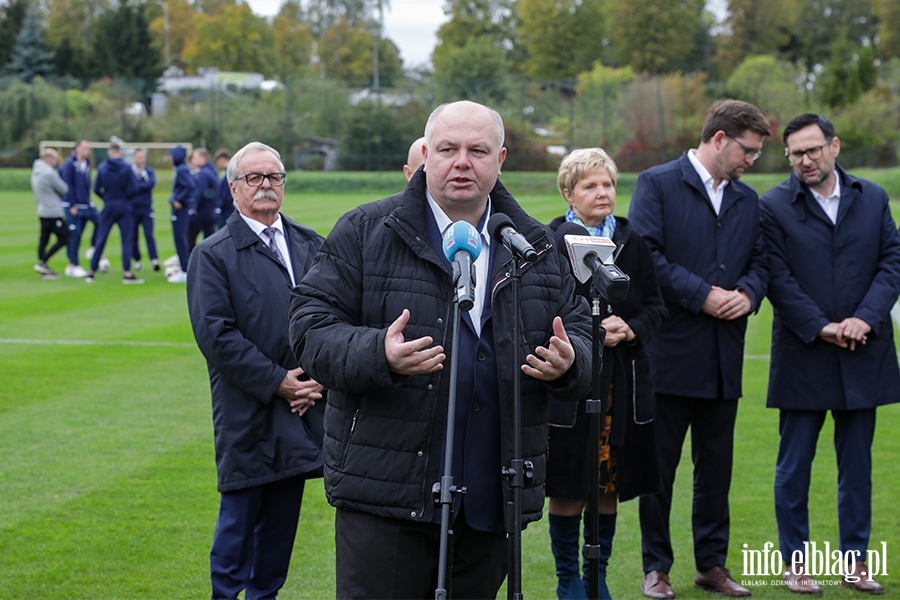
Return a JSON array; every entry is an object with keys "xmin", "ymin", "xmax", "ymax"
[{"xmin": 503, "ymin": 255, "xmax": 534, "ymax": 600}]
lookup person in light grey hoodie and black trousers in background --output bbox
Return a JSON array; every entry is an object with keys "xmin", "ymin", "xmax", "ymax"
[{"xmin": 31, "ymin": 148, "xmax": 69, "ymax": 279}]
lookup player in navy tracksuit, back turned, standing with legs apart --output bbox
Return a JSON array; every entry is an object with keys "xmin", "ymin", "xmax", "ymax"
[{"xmin": 85, "ymin": 143, "xmax": 144, "ymax": 283}]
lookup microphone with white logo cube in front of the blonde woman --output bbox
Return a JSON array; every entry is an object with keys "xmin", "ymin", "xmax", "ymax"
[{"xmin": 556, "ymin": 222, "xmax": 631, "ymax": 301}]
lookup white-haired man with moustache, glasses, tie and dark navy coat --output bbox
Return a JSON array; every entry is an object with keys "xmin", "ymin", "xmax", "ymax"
[{"xmin": 187, "ymin": 142, "xmax": 324, "ymax": 600}]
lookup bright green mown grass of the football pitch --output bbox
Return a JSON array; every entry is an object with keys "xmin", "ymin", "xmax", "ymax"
[{"xmin": 0, "ymin": 170, "xmax": 900, "ymax": 599}]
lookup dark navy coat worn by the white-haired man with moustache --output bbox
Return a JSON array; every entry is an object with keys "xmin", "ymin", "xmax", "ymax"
[{"xmin": 187, "ymin": 212, "xmax": 325, "ymax": 492}]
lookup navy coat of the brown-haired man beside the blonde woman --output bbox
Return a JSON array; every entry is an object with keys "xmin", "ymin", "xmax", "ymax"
[{"xmin": 628, "ymin": 153, "xmax": 768, "ymax": 398}]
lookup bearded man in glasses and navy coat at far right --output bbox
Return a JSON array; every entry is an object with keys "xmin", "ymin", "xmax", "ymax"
[{"xmin": 762, "ymin": 114, "xmax": 900, "ymax": 594}]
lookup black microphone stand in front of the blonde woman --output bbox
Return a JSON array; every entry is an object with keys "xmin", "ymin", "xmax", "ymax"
[{"xmin": 584, "ymin": 286, "xmax": 606, "ymax": 600}]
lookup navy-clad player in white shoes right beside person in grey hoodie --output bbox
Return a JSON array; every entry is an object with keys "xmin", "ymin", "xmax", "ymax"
[{"xmin": 59, "ymin": 140, "xmax": 99, "ymax": 277}]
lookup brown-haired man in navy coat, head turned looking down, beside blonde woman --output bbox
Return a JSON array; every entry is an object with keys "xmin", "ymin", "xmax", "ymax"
[{"xmin": 628, "ymin": 100, "xmax": 770, "ymax": 598}]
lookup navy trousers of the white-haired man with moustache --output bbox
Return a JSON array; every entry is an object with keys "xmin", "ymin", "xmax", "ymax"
[{"xmin": 209, "ymin": 477, "xmax": 306, "ymax": 600}]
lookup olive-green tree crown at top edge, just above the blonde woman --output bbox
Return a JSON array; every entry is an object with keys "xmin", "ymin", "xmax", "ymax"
[{"xmin": 517, "ymin": 0, "xmax": 606, "ymax": 80}]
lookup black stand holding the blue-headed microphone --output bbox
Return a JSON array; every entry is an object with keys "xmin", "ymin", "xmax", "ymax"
[{"xmin": 431, "ymin": 262, "xmax": 466, "ymax": 600}]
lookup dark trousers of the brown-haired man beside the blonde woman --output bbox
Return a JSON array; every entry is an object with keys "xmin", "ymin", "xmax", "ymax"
[{"xmin": 640, "ymin": 394, "xmax": 738, "ymax": 573}]
